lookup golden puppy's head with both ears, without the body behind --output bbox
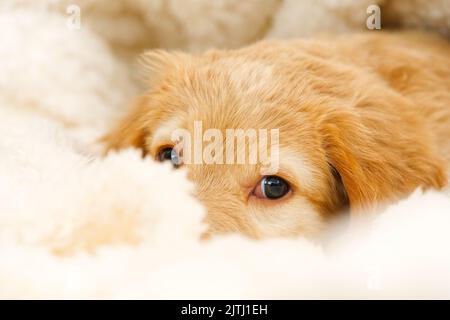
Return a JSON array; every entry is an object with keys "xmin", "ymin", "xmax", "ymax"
[{"xmin": 107, "ymin": 44, "xmax": 445, "ymax": 237}]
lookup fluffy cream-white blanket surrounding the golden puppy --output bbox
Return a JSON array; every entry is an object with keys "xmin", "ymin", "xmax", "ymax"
[{"xmin": 0, "ymin": 0, "xmax": 450, "ymax": 299}]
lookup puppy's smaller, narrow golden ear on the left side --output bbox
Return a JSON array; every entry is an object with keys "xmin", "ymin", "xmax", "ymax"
[{"xmin": 101, "ymin": 96, "xmax": 147, "ymax": 152}]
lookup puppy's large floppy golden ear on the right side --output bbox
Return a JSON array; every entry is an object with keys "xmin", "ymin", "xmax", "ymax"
[{"xmin": 322, "ymin": 101, "xmax": 447, "ymax": 213}]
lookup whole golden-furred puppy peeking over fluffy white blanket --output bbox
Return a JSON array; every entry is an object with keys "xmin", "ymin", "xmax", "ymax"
[{"xmin": 106, "ymin": 32, "xmax": 450, "ymax": 238}]
